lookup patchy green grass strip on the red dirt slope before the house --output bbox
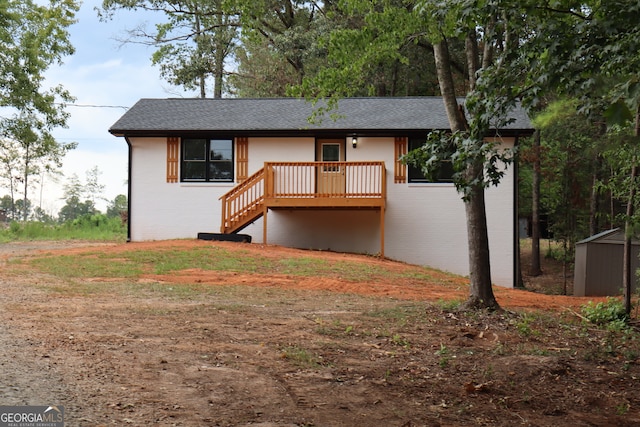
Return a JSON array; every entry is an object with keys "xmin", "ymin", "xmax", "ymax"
[{"xmin": 29, "ymin": 246, "xmax": 464, "ymax": 284}]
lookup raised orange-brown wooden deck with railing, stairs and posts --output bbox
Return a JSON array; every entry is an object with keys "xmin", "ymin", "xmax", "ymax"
[{"xmin": 220, "ymin": 161, "xmax": 387, "ymax": 256}]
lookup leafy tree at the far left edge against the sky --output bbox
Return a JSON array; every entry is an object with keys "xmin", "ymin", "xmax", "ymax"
[{"xmin": 0, "ymin": 0, "xmax": 78, "ymax": 219}]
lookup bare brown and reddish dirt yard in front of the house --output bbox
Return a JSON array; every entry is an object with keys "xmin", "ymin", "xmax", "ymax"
[{"xmin": 0, "ymin": 240, "xmax": 640, "ymax": 427}]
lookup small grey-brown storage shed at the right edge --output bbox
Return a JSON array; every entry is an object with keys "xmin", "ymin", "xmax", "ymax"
[{"xmin": 573, "ymin": 228, "xmax": 640, "ymax": 297}]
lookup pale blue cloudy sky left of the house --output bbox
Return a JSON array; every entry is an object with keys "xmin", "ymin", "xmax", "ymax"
[{"xmin": 40, "ymin": 0, "xmax": 194, "ymax": 216}]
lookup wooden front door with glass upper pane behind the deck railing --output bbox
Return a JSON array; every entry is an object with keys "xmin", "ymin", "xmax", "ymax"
[{"xmin": 316, "ymin": 139, "xmax": 346, "ymax": 194}]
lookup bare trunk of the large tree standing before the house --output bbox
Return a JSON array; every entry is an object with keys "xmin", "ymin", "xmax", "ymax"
[{"xmin": 433, "ymin": 39, "xmax": 499, "ymax": 309}]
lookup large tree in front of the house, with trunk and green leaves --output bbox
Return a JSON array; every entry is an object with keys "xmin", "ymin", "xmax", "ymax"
[{"xmin": 296, "ymin": 0, "xmax": 528, "ymax": 309}]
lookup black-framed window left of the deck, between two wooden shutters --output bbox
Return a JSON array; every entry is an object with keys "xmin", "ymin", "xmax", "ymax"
[{"xmin": 180, "ymin": 138, "xmax": 233, "ymax": 182}]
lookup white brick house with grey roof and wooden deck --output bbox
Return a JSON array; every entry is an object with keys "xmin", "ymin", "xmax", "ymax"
[{"xmin": 109, "ymin": 97, "xmax": 531, "ymax": 287}]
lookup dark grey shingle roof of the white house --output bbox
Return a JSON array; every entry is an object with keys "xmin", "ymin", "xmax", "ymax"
[{"xmin": 109, "ymin": 97, "xmax": 531, "ymax": 135}]
